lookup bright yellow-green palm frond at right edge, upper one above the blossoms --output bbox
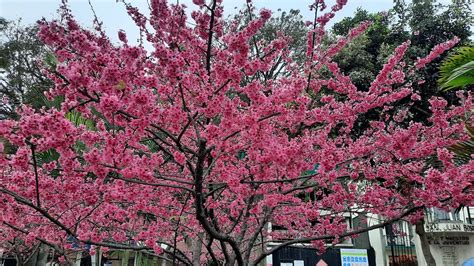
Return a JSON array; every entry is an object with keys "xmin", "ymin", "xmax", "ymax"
[{"xmin": 438, "ymin": 46, "xmax": 474, "ymax": 91}]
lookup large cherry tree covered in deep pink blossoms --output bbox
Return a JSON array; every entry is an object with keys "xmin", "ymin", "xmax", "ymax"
[{"xmin": 0, "ymin": 0, "xmax": 474, "ymax": 265}]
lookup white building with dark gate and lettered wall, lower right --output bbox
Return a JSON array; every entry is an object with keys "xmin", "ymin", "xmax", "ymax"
[{"xmin": 266, "ymin": 207, "xmax": 474, "ymax": 266}]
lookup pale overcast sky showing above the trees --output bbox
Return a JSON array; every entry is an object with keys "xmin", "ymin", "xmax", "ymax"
[{"xmin": 0, "ymin": 0, "xmax": 458, "ymax": 45}]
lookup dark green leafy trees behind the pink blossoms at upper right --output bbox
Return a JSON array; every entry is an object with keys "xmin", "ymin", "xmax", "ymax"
[{"xmin": 332, "ymin": 0, "xmax": 473, "ymax": 93}]
